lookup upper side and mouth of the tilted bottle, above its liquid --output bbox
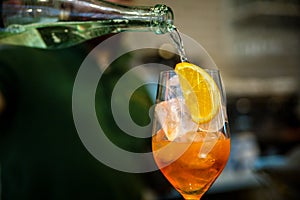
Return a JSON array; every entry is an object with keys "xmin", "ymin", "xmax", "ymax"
[{"xmin": 0, "ymin": 0, "xmax": 173, "ymax": 34}]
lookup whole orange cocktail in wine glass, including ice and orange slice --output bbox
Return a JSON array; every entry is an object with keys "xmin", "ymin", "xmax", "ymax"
[{"xmin": 152, "ymin": 62, "xmax": 230, "ymax": 200}]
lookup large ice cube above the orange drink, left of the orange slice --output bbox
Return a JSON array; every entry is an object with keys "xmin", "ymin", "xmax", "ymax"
[{"xmin": 155, "ymin": 98, "xmax": 198, "ymax": 141}]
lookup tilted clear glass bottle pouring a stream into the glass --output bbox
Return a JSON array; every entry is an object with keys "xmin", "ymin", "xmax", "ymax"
[{"xmin": 0, "ymin": 0, "xmax": 173, "ymax": 49}]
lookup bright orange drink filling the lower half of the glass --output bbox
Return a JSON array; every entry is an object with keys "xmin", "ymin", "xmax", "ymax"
[{"xmin": 152, "ymin": 130, "xmax": 230, "ymax": 199}]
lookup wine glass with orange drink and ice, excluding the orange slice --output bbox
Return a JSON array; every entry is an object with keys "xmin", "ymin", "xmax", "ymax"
[{"xmin": 152, "ymin": 69, "xmax": 230, "ymax": 200}]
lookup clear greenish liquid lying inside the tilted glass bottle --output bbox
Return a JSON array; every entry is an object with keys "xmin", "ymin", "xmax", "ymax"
[{"xmin": 0, "ymin": 20, "xmax": 151, "ymax": 49}]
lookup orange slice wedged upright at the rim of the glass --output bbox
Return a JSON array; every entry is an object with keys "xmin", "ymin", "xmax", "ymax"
[{"xmin": 175, "ymin": 62, "xmax": 221, "ymax": 124}]
